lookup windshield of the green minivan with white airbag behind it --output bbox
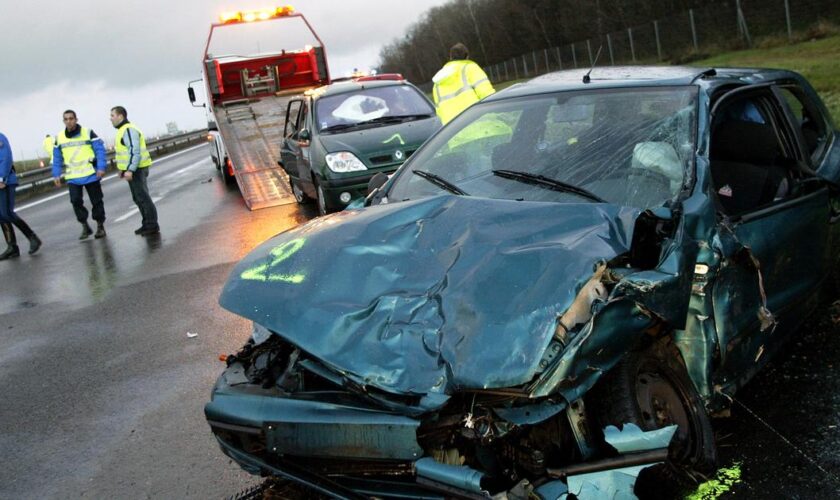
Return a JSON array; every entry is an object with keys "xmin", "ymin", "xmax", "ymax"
[{"xmin": 315, "ymin": 85, "xmax": 435, "ymax": 132}]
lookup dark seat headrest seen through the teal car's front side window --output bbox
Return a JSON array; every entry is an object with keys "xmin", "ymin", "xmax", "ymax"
[{"xmin": 709, "ymin": 121, "xmax": 781, "ymax": 165}]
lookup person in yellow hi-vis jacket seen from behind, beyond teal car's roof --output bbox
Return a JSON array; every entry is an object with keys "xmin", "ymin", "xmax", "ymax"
[{"xmin": 432, "ymin": 43, "xmax": 496, "ymax": 125}]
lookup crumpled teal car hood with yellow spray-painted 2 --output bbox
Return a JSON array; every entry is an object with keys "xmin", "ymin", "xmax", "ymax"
[{"xmin": 219, "ymin": 195, "xmax": 639, "ymax": 402}]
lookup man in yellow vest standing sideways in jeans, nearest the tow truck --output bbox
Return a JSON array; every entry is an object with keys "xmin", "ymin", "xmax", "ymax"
[{"xmin": 111, "ymin": 106, "xmax": 160, "ymax": 236}]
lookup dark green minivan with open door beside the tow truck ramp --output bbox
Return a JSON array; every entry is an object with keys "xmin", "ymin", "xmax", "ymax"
[{"xmin": 280, "ymin": 74, "xmax": 441, "ymax": 215}]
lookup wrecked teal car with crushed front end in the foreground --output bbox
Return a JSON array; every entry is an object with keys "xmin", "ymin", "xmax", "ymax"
[{"xmin": 205, "ymin": 67, "xmax": 840, "ymax": 498}]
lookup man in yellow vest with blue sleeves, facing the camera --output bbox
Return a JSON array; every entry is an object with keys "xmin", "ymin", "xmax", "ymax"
[{"xmin": 51, "ymin": 109, "xmax": 107, "ymax": 240}]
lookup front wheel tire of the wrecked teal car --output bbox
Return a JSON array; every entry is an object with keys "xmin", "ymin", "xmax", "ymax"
[{"xmin": 587, "ymin": 339, "xmax": 717, "ymax": 498}]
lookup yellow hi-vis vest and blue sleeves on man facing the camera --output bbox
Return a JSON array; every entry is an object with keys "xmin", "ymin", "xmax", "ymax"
[{"xmin": 52, "ymin": 126, "xmax": 107, "ymax": 185}]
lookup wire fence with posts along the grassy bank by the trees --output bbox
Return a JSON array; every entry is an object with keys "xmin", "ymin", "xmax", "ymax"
[{"xmin": 485, "ymin": 0, "xmax": 840, "ymax": 82}]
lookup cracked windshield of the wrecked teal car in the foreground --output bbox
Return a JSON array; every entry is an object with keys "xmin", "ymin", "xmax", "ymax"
[{"xmin": 388, "ymin": 86, "xmax": 697, "ymax": 208}]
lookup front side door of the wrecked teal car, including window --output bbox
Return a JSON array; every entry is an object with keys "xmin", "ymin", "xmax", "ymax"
[{"xmin": 709, "ymin": 85, "xmax": 831, "ymax": 386}]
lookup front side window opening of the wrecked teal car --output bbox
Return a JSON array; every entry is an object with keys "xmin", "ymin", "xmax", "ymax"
[{"xmin": 709, "ymin": 95, "xmax": 796, "ymax": 215}]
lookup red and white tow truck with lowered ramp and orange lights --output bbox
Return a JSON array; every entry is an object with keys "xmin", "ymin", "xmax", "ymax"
[{"xmin": 187, "ymin": 5, "xmax": 330, "ymax": 210}]
